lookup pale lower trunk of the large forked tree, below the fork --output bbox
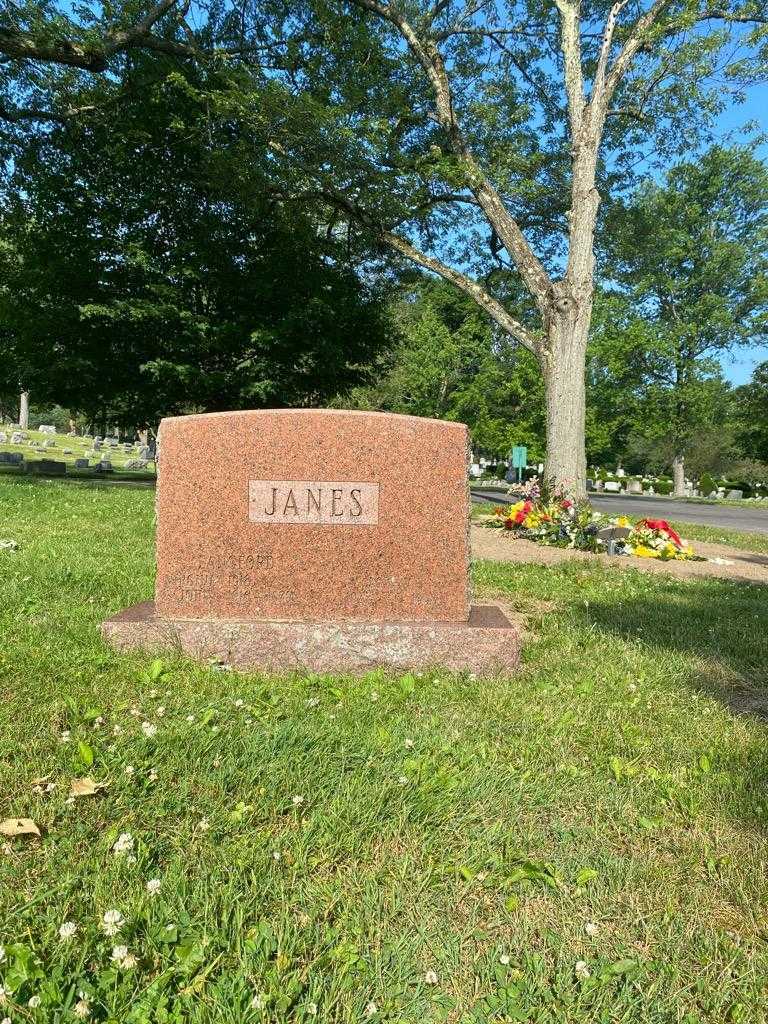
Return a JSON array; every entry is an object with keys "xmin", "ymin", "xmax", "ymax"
[{"xmin": 542, "ymin": 299, "xmax": 591, "ymax": 499}]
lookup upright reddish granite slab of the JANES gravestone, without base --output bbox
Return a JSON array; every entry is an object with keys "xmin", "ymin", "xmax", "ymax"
[{"xmin": 156, "ymin": 410, "xmax": 469, "ymax": 623}]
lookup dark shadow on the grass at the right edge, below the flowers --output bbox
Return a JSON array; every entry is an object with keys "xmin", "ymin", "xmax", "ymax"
[{"xmin": 584, "ymin": 581, "xmax": 768, "ymax": 721}]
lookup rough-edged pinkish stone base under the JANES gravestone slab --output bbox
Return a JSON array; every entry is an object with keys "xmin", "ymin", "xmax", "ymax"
[{"xmin": 101, "ymin": 601, "xmax": 520, "ymax": 676}]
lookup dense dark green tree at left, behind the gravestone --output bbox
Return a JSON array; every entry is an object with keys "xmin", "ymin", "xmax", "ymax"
[{"xmin": 0, "ymin": 65, "xmax": 388, "ymax": 424}]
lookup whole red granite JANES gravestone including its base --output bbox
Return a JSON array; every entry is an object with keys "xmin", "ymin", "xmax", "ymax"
[{"xmin": 103, "ymin": 410, "xmax": 519, "ymax": 672}]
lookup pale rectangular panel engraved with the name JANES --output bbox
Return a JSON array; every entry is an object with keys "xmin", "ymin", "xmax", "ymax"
[{"xmin": 248, "ymin": 480, "xmax": 379, "ymax": 526}]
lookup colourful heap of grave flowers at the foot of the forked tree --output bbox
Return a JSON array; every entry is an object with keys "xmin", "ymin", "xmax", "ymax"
[{"xmin": 484, "ymin": 495, "xmax": 697, "ymax": 561}]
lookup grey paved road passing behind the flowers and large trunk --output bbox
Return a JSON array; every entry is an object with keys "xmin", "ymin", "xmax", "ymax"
[{"xmin": 470, "ymin": 486, "xmax": 768, "ymax": 534}]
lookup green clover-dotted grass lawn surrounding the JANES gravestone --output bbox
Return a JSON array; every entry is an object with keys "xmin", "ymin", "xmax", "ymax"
[{"xmin": 0, "ymin": 477, "xmax": 768, "ymax": 1024}]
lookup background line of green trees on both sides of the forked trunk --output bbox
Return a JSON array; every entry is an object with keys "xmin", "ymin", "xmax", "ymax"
[{"xmin": 0, "ymin": 37, "xmax": 768, "ymax": 476}]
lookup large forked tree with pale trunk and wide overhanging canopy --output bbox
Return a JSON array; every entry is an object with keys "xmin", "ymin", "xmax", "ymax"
[{"xmin": 0, "ymin": 0, "xmax": 768, "ymax": 490}]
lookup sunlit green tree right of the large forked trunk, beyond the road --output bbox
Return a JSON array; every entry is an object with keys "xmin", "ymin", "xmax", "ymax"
[{"xmin": 589, "ymin": 146, "xmax": 768, "ymax": 475}]
